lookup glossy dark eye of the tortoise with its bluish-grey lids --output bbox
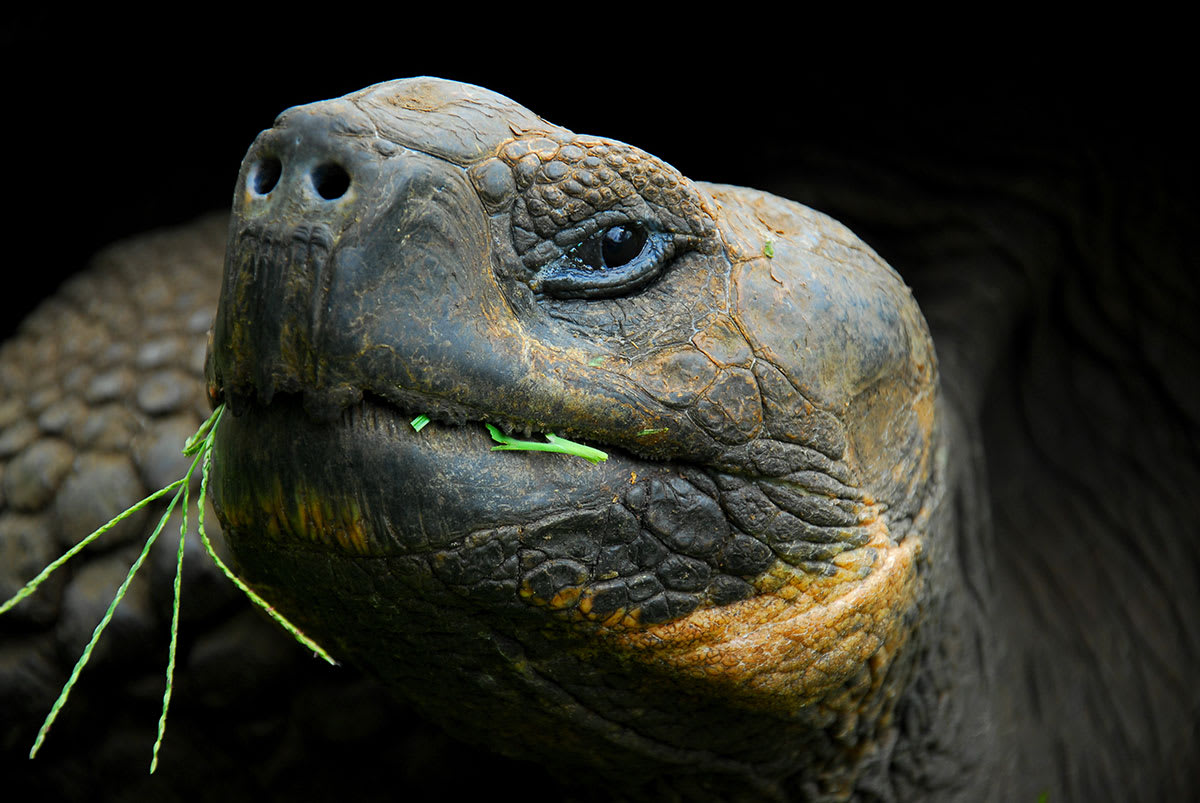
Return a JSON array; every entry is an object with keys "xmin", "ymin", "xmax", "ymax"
[{"xmin": 533, "ymin": 222, "xmax": 674, "ymax": 299}]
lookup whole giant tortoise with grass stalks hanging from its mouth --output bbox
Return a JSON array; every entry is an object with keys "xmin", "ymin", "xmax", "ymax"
[{"xmin": 0, "ymin": 72, "xmax": 1200, "ymax": 801}]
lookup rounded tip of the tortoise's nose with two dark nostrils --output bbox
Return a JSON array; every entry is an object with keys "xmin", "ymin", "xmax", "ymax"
[{"xmin": 234, "ymin": 102, "xmax": 386, "ymax": 222}]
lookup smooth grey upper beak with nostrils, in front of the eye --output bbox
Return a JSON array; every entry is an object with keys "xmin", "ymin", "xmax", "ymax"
[{"xmin": 209, "ymin": 100, "xmax": 517, "ymax": 420}]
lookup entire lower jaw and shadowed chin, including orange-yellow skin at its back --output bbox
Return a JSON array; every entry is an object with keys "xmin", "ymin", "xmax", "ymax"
[{"xmin": 214, "ymin": 398, "xmax": 920, "ymax": 771}]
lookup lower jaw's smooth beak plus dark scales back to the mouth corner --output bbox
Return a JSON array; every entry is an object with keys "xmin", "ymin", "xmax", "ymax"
[{"xmin": 206, "ymin": 384, "xmax": 878, "ymax": 628}]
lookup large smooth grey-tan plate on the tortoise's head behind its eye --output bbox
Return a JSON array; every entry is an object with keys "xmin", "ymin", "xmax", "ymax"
[{"xmin": 710, "ymin": 186, "xmax": 937, "ymax": 517}]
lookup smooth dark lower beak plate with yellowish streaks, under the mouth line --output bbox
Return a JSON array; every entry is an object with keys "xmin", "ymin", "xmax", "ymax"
[{"xmin": 205, "ymin": 394, "xmax": 644, "ymax": 555}]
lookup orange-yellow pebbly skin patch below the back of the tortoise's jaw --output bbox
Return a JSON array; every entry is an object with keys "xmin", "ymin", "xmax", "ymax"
[{"xmin": 602, "ymin": 519, "xmax": 920, "ymax": 711}]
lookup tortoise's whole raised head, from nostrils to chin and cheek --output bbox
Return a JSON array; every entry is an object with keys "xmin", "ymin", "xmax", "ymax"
[{"xmin": 209, "ymin": 78, "xmax": 941, "ymax": 784}]
